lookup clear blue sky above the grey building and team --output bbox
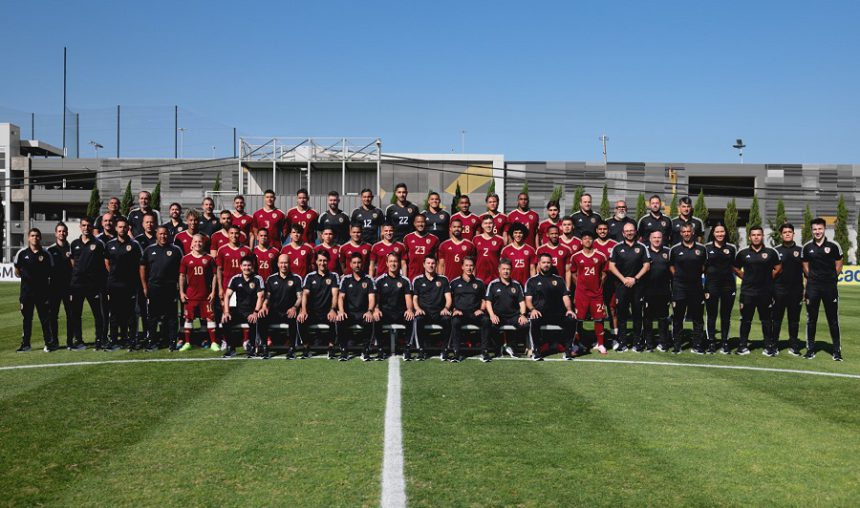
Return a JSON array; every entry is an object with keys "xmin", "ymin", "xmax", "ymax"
[{"xmin": 0, "ymin": 1, "xmax": 860, "ymax": 163}]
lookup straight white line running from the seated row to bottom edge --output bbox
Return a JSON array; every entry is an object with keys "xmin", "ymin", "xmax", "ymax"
[{"xmin": 379, "ymin": 356, "xmax": 406, "ymax": 508}]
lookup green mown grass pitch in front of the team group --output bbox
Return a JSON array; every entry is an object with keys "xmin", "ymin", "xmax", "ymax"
[{"xmin": 0, "ymin": 284, "xmax": 860, "ymax": 507}]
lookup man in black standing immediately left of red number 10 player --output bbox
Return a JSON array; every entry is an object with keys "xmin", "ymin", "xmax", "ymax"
[{"xmin": 140, "ymin": 226, "xmax": 182, "ymax": 351}]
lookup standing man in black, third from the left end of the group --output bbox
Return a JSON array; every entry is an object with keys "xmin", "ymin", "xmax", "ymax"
[{"xmin": 69, "ymin": 217, "xmax": 107, "ymax": 349}]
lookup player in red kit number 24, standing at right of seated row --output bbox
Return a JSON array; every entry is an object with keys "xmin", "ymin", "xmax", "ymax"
[{"xmin": 570, "ymin": 231, "xmax": 609, "ymax": 355}]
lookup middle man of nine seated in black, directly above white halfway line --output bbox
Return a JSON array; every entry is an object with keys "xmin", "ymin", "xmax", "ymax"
[{"xmin": 374, "ymin": 252, "xmax": 415, "ymax": 360}]
